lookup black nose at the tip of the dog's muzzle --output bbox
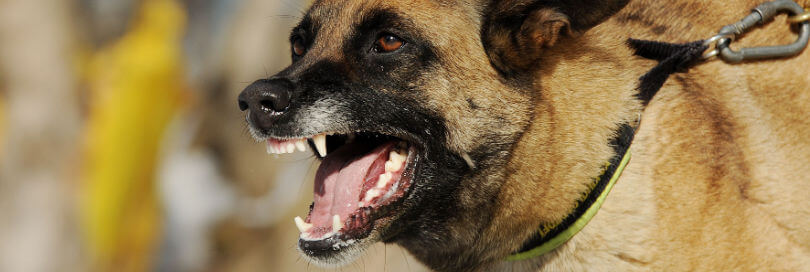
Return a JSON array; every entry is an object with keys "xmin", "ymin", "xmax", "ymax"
[{"xmin": 239, "ymin": 79, "xmax": 292, "ymax": 113}]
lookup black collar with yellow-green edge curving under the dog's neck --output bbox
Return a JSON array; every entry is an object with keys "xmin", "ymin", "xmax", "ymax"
[{"xmin": 506, "ymin": 124, "xmax": 635, "ymax": 261}]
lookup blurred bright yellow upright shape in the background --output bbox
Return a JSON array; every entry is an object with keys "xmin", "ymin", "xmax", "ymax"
[{"xmin": 81, "ymin": 0, "xmax": 187, "ymax": 271}]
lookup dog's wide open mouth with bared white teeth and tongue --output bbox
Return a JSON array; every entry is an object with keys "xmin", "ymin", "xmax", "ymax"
[{"xmin": 267, "ymin": 132, "xmax": 416, "ymax": 256}]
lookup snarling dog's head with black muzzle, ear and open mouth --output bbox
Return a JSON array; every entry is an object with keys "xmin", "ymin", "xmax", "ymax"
[{"xmin": 239, "ymin": 0, "xmax": 623, "ymax": 269}]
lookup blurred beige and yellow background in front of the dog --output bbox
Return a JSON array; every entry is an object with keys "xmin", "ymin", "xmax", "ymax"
[{"xmin": 0, "ymin": 0, "xmax": 425, "ymax": 272}]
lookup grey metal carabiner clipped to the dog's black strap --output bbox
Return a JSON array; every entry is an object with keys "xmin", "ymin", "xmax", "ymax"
[{"xmin": 704, "ymin": 0, "xmax": 810, "ymax": 63}]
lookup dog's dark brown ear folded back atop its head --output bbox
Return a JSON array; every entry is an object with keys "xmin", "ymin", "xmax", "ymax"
[{"xmin": 481, "ymin": 0, "xmax": 628, "ymax": 74}]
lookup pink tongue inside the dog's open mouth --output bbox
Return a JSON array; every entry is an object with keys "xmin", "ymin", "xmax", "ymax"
[{"xmin": 309, "ymin": 143, "xmax": 394, "ymax": 231}]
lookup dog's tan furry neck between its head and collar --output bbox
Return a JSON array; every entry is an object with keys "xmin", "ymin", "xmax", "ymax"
[{"xmin": 474, "ymin": 23, "xmax": 652, "ymax": 270}]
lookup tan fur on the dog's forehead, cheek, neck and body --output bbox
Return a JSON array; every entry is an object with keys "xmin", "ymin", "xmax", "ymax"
[{"xmin": 280, "ymin": 0, "xmax": 810, "ymax": 271}]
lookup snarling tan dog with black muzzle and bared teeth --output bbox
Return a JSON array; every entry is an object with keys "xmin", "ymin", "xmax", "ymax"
[{"xmin": 239, "ymin": 0, "xmax": 810, "ymax": 271}]
